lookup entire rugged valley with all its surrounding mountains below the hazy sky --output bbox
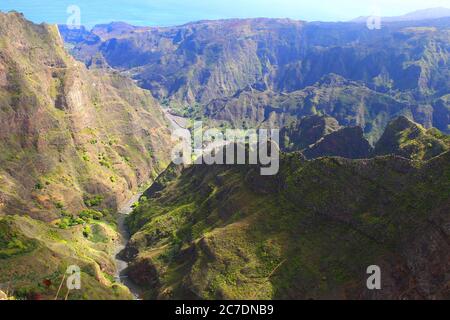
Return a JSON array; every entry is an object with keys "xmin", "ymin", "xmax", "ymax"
[{"xmin": 0, "ymin": 8, "xmax": 450, "ymax": 300}]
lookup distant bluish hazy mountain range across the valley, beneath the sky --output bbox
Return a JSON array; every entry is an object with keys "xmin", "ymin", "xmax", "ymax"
[{"xmin": 61, "ymin": 18, "xmax": 450, "ymax": 138}]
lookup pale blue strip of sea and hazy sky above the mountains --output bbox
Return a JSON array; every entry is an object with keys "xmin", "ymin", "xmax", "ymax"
[{"xmin": 0, "ymin": 0, "xmax": 450, "ymax": 26}]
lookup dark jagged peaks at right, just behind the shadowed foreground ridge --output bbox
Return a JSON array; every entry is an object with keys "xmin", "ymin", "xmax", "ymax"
[{"xmin": 280, "ymin": 115, "xmax": 450, "ymax": 161}]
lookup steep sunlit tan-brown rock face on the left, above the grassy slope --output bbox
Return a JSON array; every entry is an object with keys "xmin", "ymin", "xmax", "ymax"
[{"xmin": 0, "ymin": 13, "xmax": 170, "ymax": 220}]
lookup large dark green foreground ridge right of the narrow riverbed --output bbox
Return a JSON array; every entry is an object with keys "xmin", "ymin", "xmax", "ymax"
[{"xmin": 126, "ymin": 152, "xmax": 450, "ymax": 299}]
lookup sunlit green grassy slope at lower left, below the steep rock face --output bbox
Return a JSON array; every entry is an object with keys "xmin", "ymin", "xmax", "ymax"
[{"xmin": 0, "ymin": 216, "xmax": 131, "ymax": 299}]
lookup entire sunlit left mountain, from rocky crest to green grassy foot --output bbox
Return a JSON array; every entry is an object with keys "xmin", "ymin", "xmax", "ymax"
[{"xmin": 0, "ymin": 12, "xmax": 171, "ymax": 299}]
